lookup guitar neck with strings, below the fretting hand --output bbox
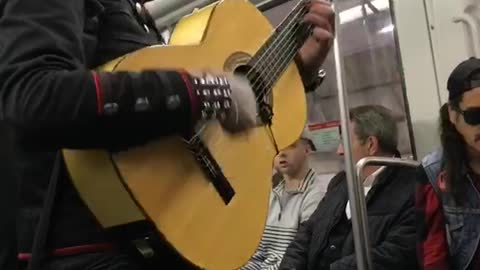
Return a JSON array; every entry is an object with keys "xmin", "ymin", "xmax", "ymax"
[{"xmin": 248, "ymin": 0, "xmax": 312, "ymax": 88}]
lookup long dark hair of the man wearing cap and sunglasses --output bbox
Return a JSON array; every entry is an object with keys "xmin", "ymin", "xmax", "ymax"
[{"xmin": 439, "ymin": 96, "xmax": 468, "ymax": 202}]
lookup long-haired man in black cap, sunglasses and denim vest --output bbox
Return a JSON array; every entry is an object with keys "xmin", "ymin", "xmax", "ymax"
[{"xmin": 416, "ymin": 58, "xmax": 480, "ymax": 270}]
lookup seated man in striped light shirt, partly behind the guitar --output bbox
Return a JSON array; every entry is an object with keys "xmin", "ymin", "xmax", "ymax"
[{"xmin": 242, "ymin": 137, "xmax": 328, "ymax": 270}]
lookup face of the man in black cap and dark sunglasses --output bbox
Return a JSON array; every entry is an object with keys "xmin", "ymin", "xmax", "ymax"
[{"xmin": 449, "ymin": 87, "xmax": 480, "ymax": 153}]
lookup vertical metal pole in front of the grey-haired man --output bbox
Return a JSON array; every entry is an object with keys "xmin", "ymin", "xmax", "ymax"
[{"xmin": 332, "ymin": 2, "xmax": 373, "ymax": 270}]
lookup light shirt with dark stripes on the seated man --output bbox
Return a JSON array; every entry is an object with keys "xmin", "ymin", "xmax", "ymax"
[{"xmin": 242, "ymin": 169, "xmax": 328, "ymax": 270}]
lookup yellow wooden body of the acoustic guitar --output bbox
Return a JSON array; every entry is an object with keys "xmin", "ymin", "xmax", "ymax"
[{"xmin": 63, "ymin": 0, "xmax": 306, "ymax": 270}]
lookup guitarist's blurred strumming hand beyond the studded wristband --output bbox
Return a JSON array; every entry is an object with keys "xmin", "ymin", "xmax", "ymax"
[{"xmin": 220, "ymin": 75, "xmax": 257, "ymax": 133}]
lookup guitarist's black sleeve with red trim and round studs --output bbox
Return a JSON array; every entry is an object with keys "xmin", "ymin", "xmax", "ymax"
[{"xmin": 0, "ymin": 0, "xmax": 197, "ymax": 149}]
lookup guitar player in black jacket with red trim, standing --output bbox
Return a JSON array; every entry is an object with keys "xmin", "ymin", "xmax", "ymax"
[{"xmin": 0, "ymin": 0, "xmax": 334, "ymax": 270}]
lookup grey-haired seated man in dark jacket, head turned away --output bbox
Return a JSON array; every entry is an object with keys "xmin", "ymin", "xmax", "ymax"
[{"xmin": 280, "ymin": 106, "xmax": 416, "ymax": 270}]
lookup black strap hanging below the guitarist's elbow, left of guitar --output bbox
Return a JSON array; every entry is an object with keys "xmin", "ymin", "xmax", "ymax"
[{"xmin": 27, "ymin": 151, "xmax": 62, "ymax": 270}]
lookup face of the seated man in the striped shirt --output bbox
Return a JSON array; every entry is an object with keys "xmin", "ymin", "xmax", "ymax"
[{"xmin": 274, "ymin": 139, "xmax": 309, "ymax": 176}]
